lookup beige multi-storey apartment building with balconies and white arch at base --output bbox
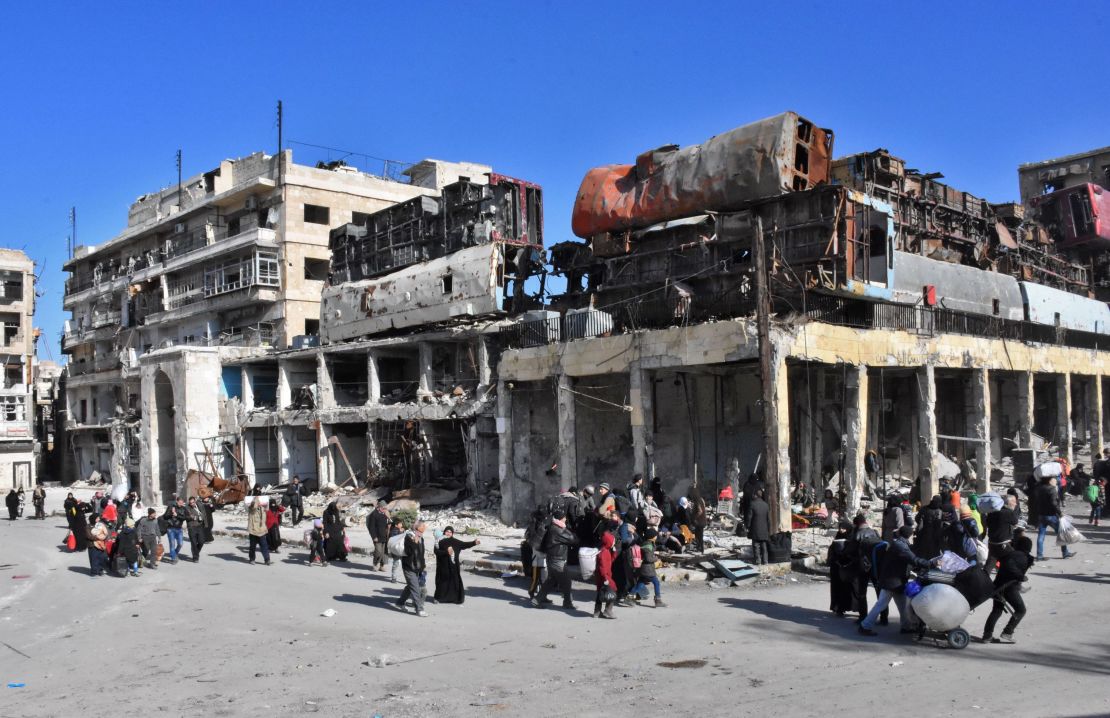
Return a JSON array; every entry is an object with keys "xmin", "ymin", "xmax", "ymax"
[{"xmin": 63, "ymin": 150, "xmax": 490, "ymax": 500}]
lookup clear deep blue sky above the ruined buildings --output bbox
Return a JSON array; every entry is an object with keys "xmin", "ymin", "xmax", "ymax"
[{"xmin": 0, "ymin": 1, "xmax": 1110, "ymax": 358}]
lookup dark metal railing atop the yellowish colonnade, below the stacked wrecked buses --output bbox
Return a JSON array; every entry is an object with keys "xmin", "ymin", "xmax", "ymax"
[{"xmin": 500, "ymin": 294, "xmax": 1110, "ymax": 351}]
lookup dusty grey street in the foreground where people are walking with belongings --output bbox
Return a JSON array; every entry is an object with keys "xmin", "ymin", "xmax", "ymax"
[{"xmin": 0, "ymin": 499, "xmax": 1110, "ymax": 718}]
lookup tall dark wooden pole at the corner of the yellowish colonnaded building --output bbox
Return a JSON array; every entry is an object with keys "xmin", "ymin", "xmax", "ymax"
[{"xmin": 751, "ymin": 215, "xmax": 783, "ymax": 533}]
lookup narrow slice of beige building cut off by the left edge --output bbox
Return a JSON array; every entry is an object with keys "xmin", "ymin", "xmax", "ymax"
[{"xmin": 0, "ymin": 249, "xmax": 36, "ymax": 491}]
